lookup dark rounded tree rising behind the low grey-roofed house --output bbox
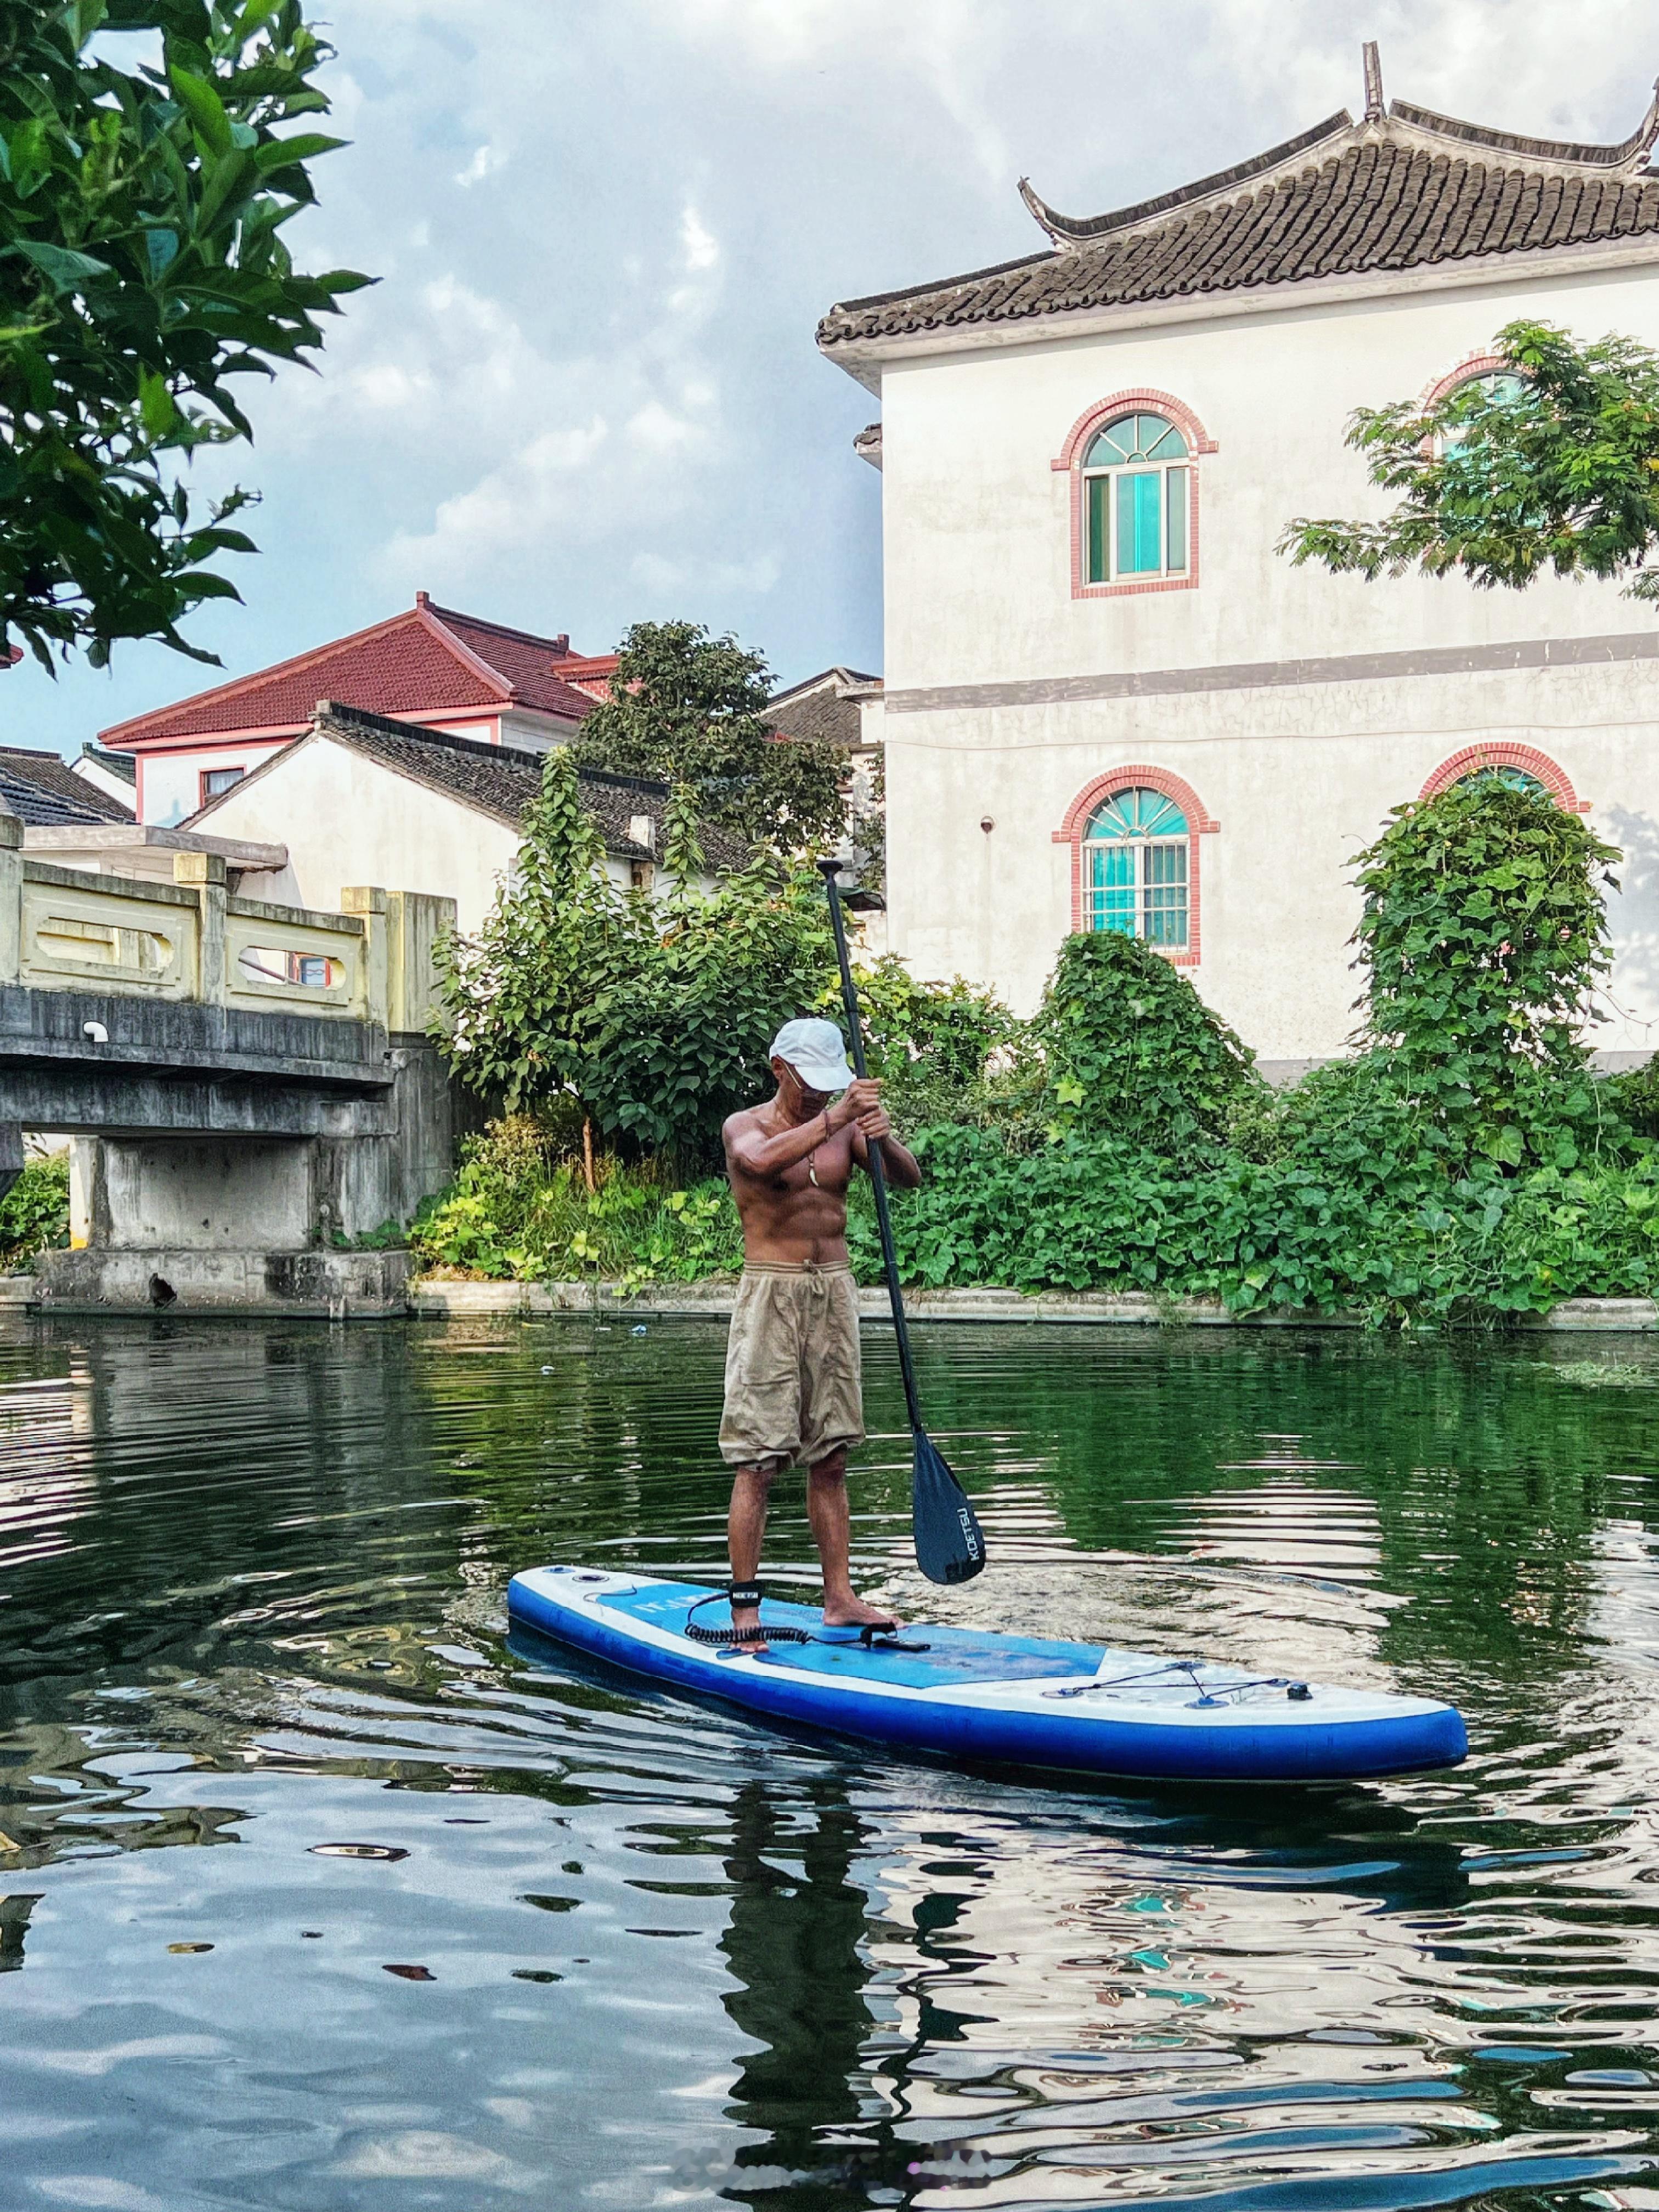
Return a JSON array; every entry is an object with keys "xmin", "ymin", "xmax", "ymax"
[{"xmin": 575, "ymin": 622, "xmax": 847, "ymax": 854}]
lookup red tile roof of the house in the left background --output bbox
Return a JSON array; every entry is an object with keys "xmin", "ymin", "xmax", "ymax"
[{"xmin": 99, "ymin": 591, "xmax": 593, "ymax": 750}]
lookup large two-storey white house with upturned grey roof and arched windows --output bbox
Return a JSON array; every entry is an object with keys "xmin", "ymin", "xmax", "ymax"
[{"xmin": 819, "ymin": 51, "xmax": 1659, "ymax": 1073}]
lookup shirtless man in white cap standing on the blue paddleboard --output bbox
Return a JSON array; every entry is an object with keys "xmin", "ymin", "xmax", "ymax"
[{"xmin": 721, "ymin": 1020, "xmax": 922, "ymax": 1641}]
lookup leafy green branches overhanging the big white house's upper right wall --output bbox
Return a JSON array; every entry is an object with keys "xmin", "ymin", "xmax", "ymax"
[{"xmin": 1278, "ymin": 323, "xmax": 1659, "ymax": 600}]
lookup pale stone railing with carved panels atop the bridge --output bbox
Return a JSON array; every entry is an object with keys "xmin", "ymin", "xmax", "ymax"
[{"xmin": 0, "ymin": 816, "xmax": 454, "ymax": 1033}]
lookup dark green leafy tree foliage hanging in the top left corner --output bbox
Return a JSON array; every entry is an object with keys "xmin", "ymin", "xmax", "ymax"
[{"xmin": 0, "ymin": 0, "xmax": 369, "ymax": 668}]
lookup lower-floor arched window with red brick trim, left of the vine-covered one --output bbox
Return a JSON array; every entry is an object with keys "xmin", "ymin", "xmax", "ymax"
[{"xmin": 1053, "ymin": 763, "xmax": 1221, "ymax": 967}]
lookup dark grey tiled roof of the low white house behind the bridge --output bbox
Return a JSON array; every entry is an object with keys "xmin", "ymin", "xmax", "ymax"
[{"xmin": 188, "ymin": 703, "xmax": 748, "ymax": 867}]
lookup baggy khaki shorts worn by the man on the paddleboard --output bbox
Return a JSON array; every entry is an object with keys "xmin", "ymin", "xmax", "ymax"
[{"xmin": 721, "ymin": 1261, "xmax": 865, "ymax": 1466}]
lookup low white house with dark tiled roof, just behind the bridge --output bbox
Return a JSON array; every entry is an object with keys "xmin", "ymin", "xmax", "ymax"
[{"xmin": 188, "ymin": 706, "xmax": 746, "ymax": 931}]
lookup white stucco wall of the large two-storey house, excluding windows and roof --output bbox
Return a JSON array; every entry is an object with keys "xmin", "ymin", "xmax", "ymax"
[{"xmin": 881, "ymin": 254, "xmax": 1659, "ymax": 1059}]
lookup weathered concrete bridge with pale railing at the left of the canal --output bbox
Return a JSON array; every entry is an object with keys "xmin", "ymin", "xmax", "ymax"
[{"xmin": 0, "ymin": 814, "xmax": 456, "ymax": 1314}]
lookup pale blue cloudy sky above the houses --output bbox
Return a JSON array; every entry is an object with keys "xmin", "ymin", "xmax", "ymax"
[{"xmin": 13, "ymin": 0, "xmax": 1659, "ymax": 754}]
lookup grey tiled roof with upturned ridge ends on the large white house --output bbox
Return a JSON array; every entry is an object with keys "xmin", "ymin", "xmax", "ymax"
[{"xmin": 819, "ymin": 74, "xmax": 1659, "ymax": 354}]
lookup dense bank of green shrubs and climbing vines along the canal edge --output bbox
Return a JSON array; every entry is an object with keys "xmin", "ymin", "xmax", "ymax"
[{"xmin": 429, "ymin": 770, "xmax": 1659, "ymax": 1323}]
